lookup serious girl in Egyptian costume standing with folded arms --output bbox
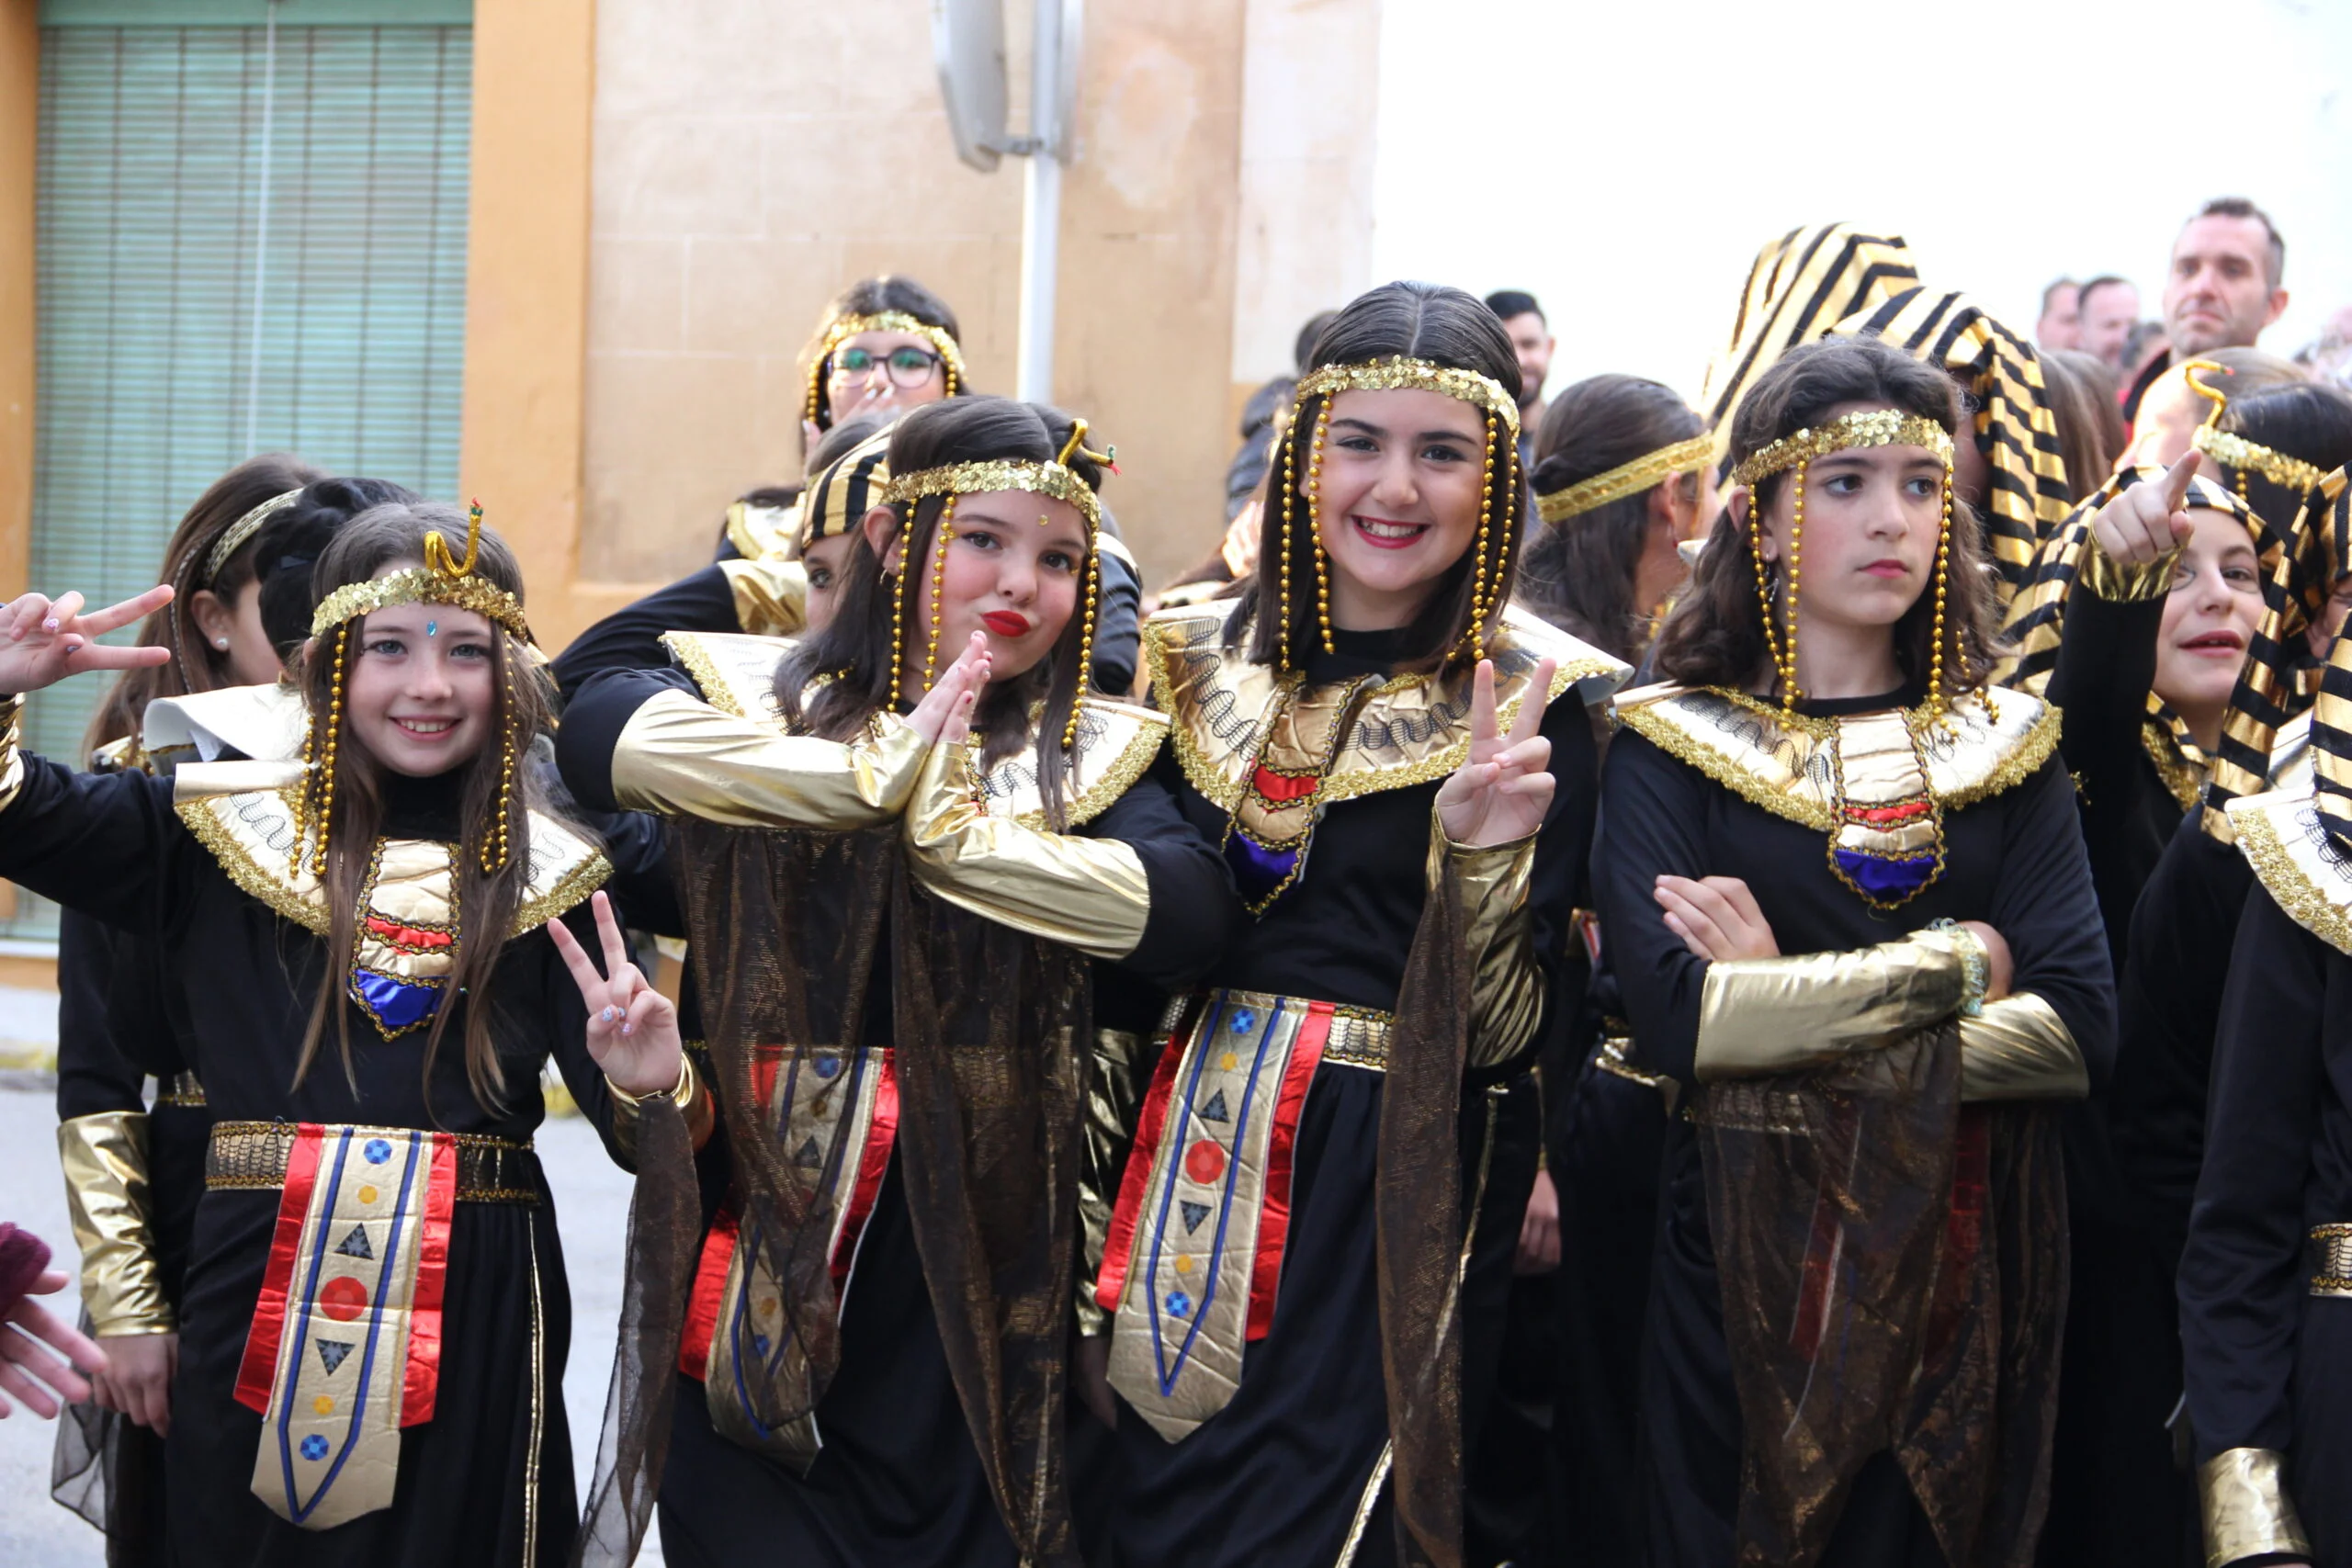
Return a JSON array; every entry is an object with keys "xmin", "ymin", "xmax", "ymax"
[{"xmin": 1592, "ymin": 339, "xmax": 2112, "ymax": 1568}]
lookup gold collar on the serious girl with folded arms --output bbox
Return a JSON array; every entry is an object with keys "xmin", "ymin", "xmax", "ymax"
[{"xmin": 1618, "ymin": 686, "xmax": 2058, "ymax": 832}]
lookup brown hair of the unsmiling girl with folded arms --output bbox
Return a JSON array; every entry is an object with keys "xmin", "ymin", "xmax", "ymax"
[{"xmin": 1656, "ymin": 339, "xmax": 1999, "ymax": 691}]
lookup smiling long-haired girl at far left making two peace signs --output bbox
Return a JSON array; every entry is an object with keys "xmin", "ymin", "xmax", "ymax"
[{"xmin": 0, "ymin": 505, "xmax": 677, "ymax": 1568}]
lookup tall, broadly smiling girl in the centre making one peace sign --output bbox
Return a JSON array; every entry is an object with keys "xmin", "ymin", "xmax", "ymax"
[{"xmin": 1082, "ymin": 282, "xmax": 1625, "ymax": 1565}]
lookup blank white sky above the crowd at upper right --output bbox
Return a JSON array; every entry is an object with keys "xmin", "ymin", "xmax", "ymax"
[{"xmin": 1374, "ymin": 0, "xmax": 2352, "ymax": 398}]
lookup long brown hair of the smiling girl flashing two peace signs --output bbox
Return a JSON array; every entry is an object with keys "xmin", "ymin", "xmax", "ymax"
[{"xmin": 294, "ymin": 501, "xmax": 553, "ymax": 1110}]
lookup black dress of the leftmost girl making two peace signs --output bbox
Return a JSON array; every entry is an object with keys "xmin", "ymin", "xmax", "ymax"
[{"xmin": 0, "ymin": 757, "xmax": 630, "ymax": 1568}]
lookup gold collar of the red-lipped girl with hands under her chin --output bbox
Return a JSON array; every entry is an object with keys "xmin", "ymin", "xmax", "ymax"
[{"xmin": 663, "ymin": 632, "xmax": 1169, "ymax": 828}]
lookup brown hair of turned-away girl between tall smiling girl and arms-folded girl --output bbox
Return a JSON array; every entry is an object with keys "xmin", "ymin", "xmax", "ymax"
[{"xmin": 1520, "ymin": 376, "xmax": 1705, "ymax": 663}]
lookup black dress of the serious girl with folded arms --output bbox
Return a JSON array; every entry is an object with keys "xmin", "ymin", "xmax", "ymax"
[{"xmin": 1592, "ymin": 694, "xmax": 2112, "ymax": 1568}]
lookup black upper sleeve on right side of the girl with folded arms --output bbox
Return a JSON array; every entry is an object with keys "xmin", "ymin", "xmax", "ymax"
[{"xmin": 1987, "ymin": 757, "xmax": 2114, "ymax": 1093}]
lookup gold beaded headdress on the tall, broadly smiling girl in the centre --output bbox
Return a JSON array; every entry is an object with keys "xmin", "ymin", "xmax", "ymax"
[{"xmin": 1280, "ymin": 355, "xmax": 1524, "ymax": 670}]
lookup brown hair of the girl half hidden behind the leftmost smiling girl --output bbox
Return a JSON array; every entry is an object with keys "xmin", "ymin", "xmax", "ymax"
[{"xmin": 83, "ymin": 451, "xmax": 320, "ymax": 755}]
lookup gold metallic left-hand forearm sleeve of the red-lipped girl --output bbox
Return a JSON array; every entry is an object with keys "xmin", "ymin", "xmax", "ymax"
[{"xmin": 612, "ymin": 691, "xmax": 932, "ymax": 832}]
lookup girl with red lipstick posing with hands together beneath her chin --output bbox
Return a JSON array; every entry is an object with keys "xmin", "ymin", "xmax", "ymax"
[{"xmin": 558, "ymin": 398, "xmax": 1238, "ymax": 1568}]
